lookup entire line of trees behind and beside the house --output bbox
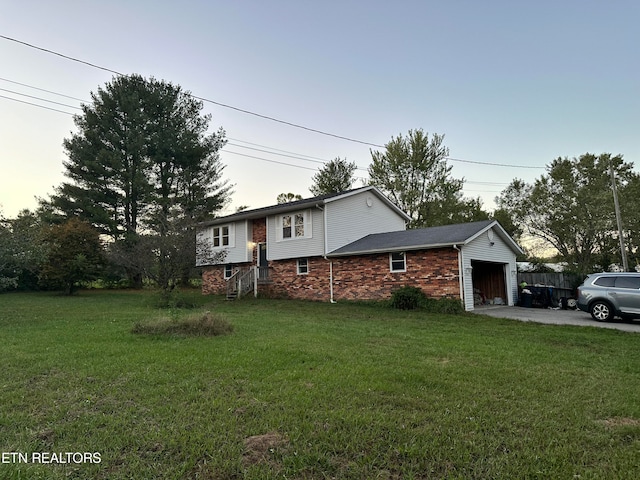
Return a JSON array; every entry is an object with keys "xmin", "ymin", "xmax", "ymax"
[{"xmin": 0, "ymin": 75, "xmax": 640, "ymax": 295}]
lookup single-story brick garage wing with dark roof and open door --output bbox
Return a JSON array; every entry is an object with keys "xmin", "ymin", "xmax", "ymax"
[{"xmin": 327, "ymin": 220, "xmax": 522, "ymax": 310}]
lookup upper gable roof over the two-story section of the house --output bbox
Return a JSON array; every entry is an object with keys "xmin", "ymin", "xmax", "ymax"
[{"xmin": 198, "ymin": 186, "xmax": 411, "ymax": 227}]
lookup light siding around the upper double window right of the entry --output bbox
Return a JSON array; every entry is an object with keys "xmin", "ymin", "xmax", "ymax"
[{"xmin": 267, "ymin": 208, "xmax": 324, "ymax": 260}]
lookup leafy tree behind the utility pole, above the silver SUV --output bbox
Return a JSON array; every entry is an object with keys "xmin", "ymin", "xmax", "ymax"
[{"xmin": 496, "ymin": 153, "xmax": 640, "ymax": 274}]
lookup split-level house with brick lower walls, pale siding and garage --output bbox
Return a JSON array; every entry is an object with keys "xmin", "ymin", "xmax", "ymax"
[{"xmin": 197, "ymin": 187, "xmax": 522, "ymax": 310}]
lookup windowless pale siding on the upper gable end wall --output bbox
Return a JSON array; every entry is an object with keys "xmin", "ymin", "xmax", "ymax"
[{"xmin": 324, "ymin": 191, "xmax": 405, "ymax": 253}]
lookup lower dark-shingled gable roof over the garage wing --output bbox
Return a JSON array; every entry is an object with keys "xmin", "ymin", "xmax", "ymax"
[{"xmin": 327, "ymin": 220, "xmax": 522, "ymax": 257}]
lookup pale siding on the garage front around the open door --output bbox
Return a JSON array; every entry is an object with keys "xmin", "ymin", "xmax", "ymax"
[{"xmin": 462, "ymin": 227, "xmax": 518, "ymax": 310}]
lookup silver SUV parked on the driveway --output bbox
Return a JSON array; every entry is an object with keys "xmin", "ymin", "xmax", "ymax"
[{"xmin": 578, "ymin": 273, "xmax": 640, "ymax": 322}]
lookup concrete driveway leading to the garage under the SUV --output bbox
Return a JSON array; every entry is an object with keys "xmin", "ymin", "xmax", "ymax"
[{"xmin": 473, "ymin": 305, "xmax": 640, "ymax": 333}]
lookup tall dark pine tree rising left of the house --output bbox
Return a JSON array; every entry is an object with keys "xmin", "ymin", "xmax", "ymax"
[{"xmin": 49, "ymin": 75, "xmax": 231, "ymax": 283}]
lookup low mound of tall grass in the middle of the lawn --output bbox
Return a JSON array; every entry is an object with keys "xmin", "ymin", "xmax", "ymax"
[{"xmin": 132, "ymin": 312, "xmax": 233, "ymax": 337}]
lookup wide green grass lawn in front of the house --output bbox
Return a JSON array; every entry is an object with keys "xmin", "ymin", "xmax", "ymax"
[{"xmin": 0, "ymin": 291, "xmax": 640, "ymax": 480}]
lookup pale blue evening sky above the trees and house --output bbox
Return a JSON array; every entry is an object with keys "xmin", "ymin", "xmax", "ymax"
[{"xmin": 0, "ymin": 0, "xmax": 640, "ymax": 218}]
